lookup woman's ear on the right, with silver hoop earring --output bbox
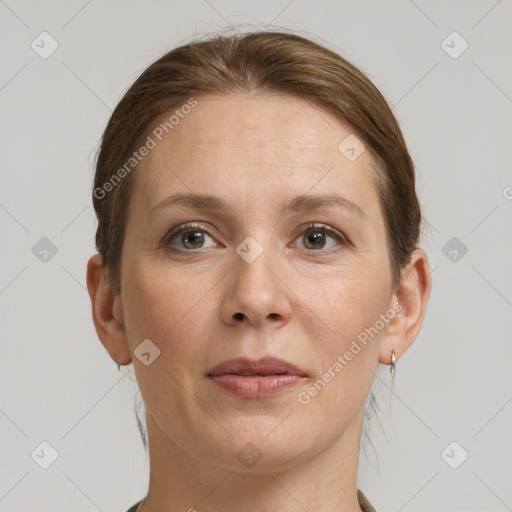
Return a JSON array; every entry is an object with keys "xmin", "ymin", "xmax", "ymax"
[{"xmin": 379, "ymin": 249, "xmax": 431, "ymax": 364}]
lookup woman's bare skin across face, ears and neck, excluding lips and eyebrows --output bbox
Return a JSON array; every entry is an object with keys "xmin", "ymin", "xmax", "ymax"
[{"xmin": 87, "ymin": 94, "xmax": 431, "ymax": 512}]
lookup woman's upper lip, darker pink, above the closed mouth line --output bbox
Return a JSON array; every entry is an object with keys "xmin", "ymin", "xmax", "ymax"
[{"xmin": 208, "ymin": 357, "xmax": 306, "ymax": 377}]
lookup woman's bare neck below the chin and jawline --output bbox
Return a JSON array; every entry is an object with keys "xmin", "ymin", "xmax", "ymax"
[{"xmin": 137, "ymin": 412, "xmax": 362, "ymax": 512}]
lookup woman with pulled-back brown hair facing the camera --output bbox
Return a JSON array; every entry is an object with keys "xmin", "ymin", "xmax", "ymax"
[{"xmin": 87, "ymin": 32, "xmax": 431, "ymax": 512}]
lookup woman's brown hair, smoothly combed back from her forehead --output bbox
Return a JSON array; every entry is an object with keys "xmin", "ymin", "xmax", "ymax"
[{"xmin": 93, "ymin": 31, "xmax": 421, "ymax": 293}]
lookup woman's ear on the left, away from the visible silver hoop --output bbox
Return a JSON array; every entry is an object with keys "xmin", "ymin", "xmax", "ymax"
[{"xmin": 87, "ymin": 254, "xmax": 131, "ymax": 365}]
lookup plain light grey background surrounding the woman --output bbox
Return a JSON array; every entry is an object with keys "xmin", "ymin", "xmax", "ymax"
[{"xmin": 0, "ymin": 0, "xmax": 512, "ymax": 512}]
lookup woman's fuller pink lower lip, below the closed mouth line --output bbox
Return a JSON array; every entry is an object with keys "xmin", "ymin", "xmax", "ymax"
[{"xmin": 210, "ymin": 373, "xmax": 304, "ymax": 398}]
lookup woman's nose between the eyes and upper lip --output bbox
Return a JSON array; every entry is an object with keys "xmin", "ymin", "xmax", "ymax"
[{"xmin": 222, "ymin": 239, "xmax": 292, "ymax": 327}]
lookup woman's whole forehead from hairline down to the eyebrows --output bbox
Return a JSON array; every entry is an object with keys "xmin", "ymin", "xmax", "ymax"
[{"xmin": 130, "ymin": 94, "xmax": 378, "ymax": 220}]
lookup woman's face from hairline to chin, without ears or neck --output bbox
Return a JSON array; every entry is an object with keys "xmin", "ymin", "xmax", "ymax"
[{"xmin": 116, "ymin": 95, "xmax": 396, "ymax": 471}]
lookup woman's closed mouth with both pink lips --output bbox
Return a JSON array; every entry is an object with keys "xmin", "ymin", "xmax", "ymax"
[{"xmin": 207, "ymin": 357, "xmax": 307, "ymax": 399}]
